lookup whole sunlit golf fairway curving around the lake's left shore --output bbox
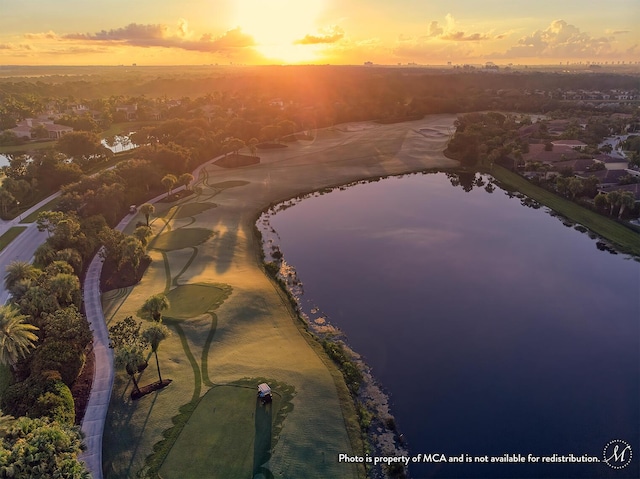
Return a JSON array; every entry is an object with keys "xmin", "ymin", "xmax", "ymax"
[{"xmin": 102, "ymin": 115, "xmax": 457, "ymax": 479}]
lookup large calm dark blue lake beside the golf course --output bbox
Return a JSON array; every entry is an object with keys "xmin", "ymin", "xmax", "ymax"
[{"xmin": 264, "ymin": 174, "xmax": 640, "ymax": 478}]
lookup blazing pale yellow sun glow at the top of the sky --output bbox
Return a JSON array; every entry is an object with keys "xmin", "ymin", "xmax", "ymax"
[{"xmin": 234, "ymin": 0, "xmax": 324, "ymax": 63}]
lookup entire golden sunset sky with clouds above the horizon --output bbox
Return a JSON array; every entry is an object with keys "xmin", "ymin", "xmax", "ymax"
[{"xmin": 0, "ymin": 0, "xmax": 640, "ymax": 65}]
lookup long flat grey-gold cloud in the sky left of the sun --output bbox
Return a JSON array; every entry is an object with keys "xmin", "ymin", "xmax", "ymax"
[{"xmin": 60, "ymin": 19, "xmax": 256, "ymax": 53}]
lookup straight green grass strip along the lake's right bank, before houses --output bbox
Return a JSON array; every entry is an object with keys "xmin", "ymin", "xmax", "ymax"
[{"xmin": 490, "ymin": 165, "xmax": 640, "ymax": 255}]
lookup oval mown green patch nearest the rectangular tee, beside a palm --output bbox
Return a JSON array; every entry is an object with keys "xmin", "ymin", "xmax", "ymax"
[{"xmin": 164, "ymin": 284, "xmax": 231, "ymax": 319}]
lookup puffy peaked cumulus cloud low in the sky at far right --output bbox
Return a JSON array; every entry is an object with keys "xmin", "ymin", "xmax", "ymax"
[{"xmin": 501, "ymin": 20, "xmax": 613, "ymax": 58}]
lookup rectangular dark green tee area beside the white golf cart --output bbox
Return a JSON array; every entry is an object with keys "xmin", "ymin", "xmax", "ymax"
[{"xmin": 159, "ymin": 380, "xmax": 293, "ymax": 479}]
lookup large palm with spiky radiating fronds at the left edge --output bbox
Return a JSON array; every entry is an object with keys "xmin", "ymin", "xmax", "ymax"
[{"xmin": 0, "ymin": 305, "xmax": 38, "ymax": 367}]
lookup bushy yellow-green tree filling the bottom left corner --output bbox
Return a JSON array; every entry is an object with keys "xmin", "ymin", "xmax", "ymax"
[{"xmin": 0, "ymin": 417, "xmax": 91, "ymax": 479}]
